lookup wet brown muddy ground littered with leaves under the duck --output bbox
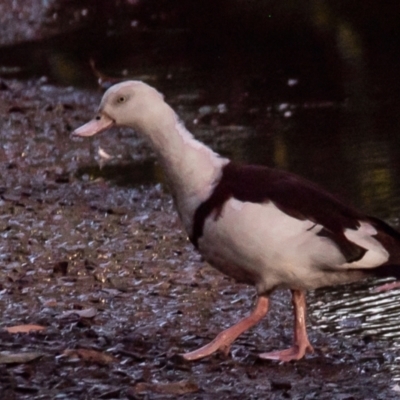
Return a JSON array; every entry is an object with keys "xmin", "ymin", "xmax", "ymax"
[{"xmin": 0, "ymin": 79, "xmax": 400, "ymax": 400}]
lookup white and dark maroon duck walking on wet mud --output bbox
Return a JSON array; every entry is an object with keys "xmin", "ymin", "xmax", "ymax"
[{"xmin": 73, "ymin": 81, "xmax": 400, "ymax": 362}]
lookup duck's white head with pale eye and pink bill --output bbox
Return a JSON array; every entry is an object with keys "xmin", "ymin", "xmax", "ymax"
[{"xmin": 73, "ymin": 81, "xmax": 166, "ymax": 136}]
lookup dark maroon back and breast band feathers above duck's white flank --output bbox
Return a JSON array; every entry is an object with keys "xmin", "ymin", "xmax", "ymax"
[{"xmin": 191, "ymin": 163, "xmax": 366, "ymax": 262}]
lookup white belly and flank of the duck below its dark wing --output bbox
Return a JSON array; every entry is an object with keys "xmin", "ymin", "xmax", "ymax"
[{"xmin": 198, "ymin": 199, "xmax": 386, "ymax": 292}]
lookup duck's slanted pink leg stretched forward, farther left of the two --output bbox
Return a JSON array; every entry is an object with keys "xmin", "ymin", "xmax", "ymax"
[{"xmin": 182, "ymin": 296, "xmax": 269, "ymax": 361}]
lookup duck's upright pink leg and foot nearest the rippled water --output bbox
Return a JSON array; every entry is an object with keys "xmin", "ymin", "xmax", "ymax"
[{"xmin": 259, "ymin": 290, "xmax": 314, "ymax": 361}]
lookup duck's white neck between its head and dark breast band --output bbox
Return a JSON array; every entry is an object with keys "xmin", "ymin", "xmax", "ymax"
[{"xmin": 134, "ymin": 102, "xmax": 229, "ymax": 234}]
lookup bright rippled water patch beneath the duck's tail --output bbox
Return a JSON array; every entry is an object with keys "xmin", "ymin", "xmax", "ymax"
[{"xmin": 309, "ymin": 279, "xmax": 400, "ymax": 381}]
